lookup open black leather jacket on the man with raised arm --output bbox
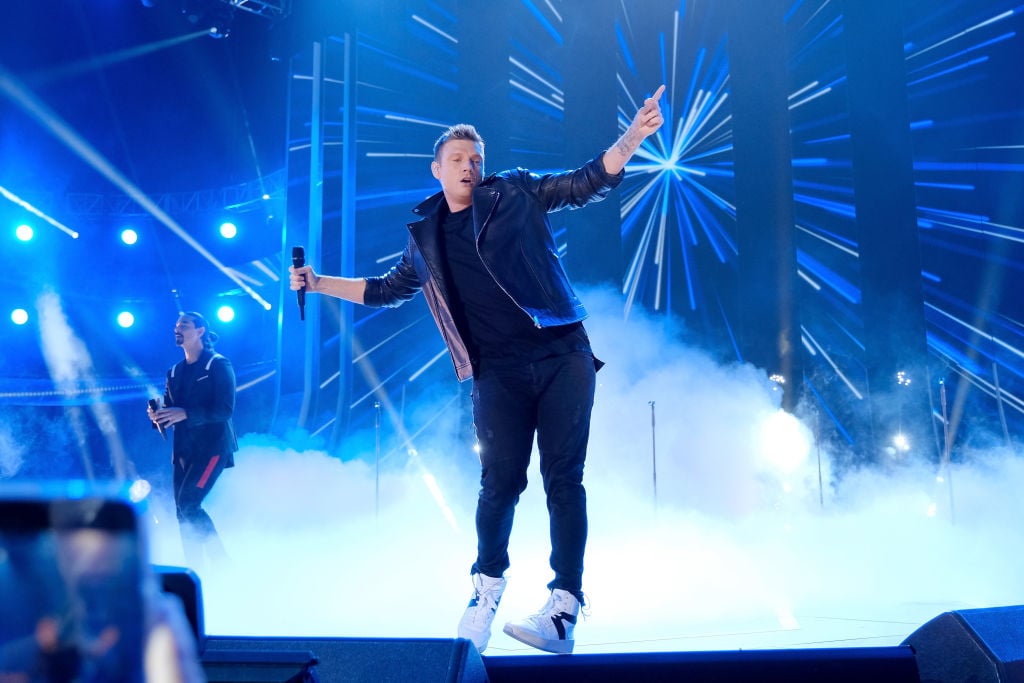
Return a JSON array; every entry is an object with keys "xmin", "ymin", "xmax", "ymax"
[{"xmin": 364, "ymin": 154, "xmax": 625, "ymax": 381}]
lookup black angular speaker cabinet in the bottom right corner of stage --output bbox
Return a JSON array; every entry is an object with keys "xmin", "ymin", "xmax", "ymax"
[{"xmin": 903, "ymin": 605, "xmax": 1024, "ymax": 683}]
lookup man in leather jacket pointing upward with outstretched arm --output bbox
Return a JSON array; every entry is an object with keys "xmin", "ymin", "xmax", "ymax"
[{"xmin": 290, "ymin": 85, "xmax": 665, "ymax": 653}]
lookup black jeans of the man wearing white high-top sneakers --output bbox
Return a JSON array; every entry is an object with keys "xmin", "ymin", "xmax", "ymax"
[{"xmin": 472, "ymin": 351, "xmax": 596, "ymax": 600}]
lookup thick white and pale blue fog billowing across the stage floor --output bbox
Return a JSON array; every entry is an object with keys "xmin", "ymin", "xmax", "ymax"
[{"xmin": 136, "ymin": 292, "xmax": 1024, "ymax": 653}]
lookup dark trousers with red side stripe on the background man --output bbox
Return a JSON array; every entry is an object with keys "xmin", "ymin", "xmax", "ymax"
[{"xmin": 174, "ymin": 454, "xmax": 226, "ymax": 568}]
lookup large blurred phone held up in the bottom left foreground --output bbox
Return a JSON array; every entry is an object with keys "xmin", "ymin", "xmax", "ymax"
[{"xmin": 0, "ymin": 498, "xmax": 143, "ymax": 683}]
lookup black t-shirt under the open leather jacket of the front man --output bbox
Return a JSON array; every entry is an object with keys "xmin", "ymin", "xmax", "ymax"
[{"xmin": 441, "ymin": 207, "xmax": 590, "ymax": 362}]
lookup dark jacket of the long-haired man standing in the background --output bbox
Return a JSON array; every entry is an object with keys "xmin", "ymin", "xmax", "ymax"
[{"xmin": 164, "ymin": 349, "xmax": 239, "ymax": 467}]
